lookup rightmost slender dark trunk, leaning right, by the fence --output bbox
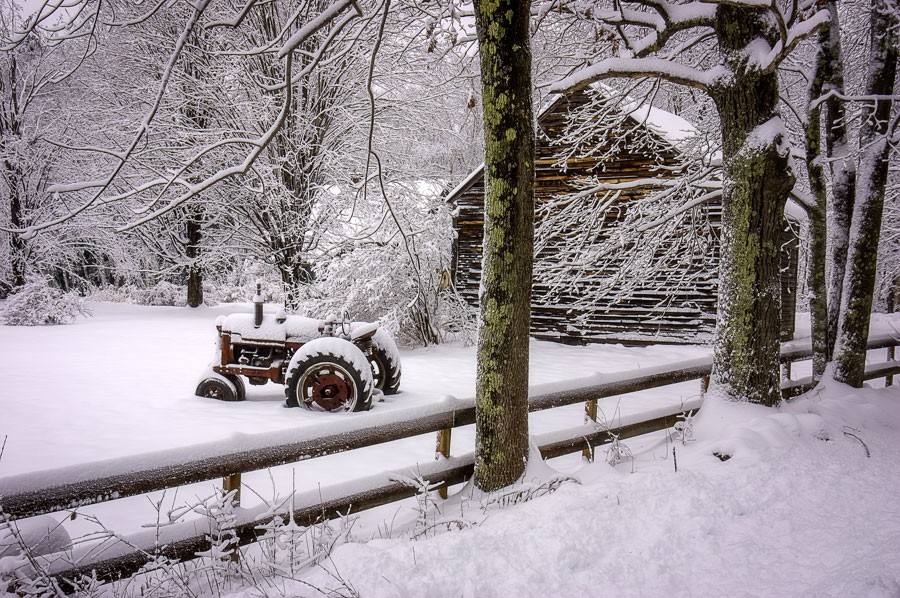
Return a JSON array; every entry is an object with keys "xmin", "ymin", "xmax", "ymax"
[{"xmin": 834, "ymin": 0, "xmax": 897, "ymax": 387}]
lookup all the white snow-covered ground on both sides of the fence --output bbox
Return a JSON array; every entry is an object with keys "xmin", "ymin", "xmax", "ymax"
[{"xmin": 0, "ymin": 303, "xmax": 900, "ymax": 598}]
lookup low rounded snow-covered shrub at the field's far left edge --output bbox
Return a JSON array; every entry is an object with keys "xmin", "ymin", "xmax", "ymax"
[{"xmin": 2, "ymin": 279, "xmax": 91, "ymax": 326}]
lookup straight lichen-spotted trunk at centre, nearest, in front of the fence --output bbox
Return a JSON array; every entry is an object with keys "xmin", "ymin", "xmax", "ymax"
[{"xmin": 475, "ymin": 0, "xmax": 534, "ymax": 491}]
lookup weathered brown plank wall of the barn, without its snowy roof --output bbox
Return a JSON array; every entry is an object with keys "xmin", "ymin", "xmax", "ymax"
[{"xmin": 448, "ymin": 86, "xmax": 796, "ymax": 344}]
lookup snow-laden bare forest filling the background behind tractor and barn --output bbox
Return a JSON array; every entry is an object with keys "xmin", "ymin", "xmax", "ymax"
[{"xmin": 0, "ymin": 0, "xmax": 900, "ymax": 352}]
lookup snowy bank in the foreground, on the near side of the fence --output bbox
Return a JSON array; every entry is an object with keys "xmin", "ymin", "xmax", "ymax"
[{"xmin": 286, "ymin": 388, "xmax": 900, "ymax": 598}]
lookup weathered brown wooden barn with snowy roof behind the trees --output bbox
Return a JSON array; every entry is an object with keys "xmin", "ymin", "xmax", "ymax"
[{"xmin": 448, "ymin": 86, "xmax": 798, "ymax": 344}]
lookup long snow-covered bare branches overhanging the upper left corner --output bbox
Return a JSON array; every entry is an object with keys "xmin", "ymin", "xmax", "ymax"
[{"xmin": 7, "ymin": 0, "xmax": 372, "ymax": 238}]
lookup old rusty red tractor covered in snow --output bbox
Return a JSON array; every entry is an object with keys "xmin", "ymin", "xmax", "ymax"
[{"xmin": 196, "ymin": 288, "xmax": 400, "ymax": 411}]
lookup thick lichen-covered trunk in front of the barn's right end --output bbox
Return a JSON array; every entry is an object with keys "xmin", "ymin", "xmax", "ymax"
[{"xmin": 711, "ymin": 5, "xmax": 793, "ymax": 405}]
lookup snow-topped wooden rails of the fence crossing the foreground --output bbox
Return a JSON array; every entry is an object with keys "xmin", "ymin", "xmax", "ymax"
[{"xmin": 0, "ymin": 335, "xmax": 900, "ymax": 580}]
